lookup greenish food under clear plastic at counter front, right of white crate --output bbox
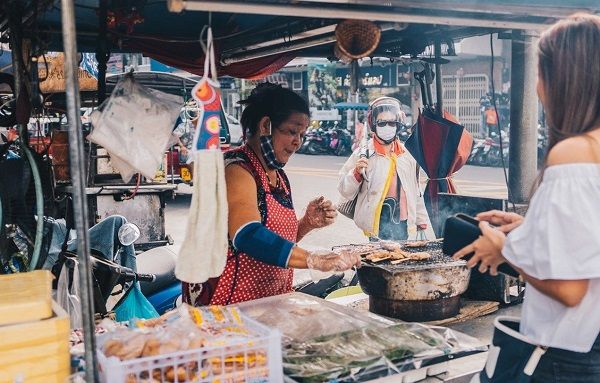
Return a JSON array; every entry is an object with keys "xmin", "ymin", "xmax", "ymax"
[{"xmin": 283, "ymin": 323, "xmax": 485, "ymax": 383}]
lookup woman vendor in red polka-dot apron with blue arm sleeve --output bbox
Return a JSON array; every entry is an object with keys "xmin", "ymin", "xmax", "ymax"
[{"xmin": 183, "ymin": 83, "xmax": 360, "ymax": 306}]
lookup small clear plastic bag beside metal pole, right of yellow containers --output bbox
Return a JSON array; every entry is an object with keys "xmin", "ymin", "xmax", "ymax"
[{"xmin": 56, "ymin": 259, "xmax": 83, "ymax": 329}]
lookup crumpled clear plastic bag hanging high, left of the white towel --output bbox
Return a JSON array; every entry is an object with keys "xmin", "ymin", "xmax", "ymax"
[{"xmin": 87, "ymin": 75, "xmax": 181, "ymax": 182}]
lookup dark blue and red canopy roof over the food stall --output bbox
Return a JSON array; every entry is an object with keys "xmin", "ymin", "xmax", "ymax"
[{"xmin": 0, "ymin": 0, "xmax": 600, "ymax": 79}]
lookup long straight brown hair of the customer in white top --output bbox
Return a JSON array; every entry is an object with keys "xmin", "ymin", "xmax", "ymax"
[{"xmin": 534, "ymin": 13, "xmax": 600, "ymax": 188}]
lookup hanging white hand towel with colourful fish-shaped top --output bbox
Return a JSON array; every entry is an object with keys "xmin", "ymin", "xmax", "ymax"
[{"xmin": 175, "ymin": 27, "xmax": 228, "ymax": 283}]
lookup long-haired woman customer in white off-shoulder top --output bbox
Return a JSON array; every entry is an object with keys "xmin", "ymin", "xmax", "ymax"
[{"xmin": 455, "ymin": 14, "xmax": 600, "ymax": 383}]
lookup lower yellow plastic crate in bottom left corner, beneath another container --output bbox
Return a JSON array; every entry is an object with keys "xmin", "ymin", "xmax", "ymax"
[{"xmin": 0, "ymin": 301, "xmax": 70, "ymax": 383}]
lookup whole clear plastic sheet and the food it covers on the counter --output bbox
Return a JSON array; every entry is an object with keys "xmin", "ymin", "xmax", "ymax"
[{"xmin": 237, "ymin": 293, "xmax": 487, "ymax": 383}]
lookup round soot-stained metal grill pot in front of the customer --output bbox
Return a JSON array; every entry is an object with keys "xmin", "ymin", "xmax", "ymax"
[{"xmin": 335, "ymin": 241, "xmax": 470, "ymax": 322}]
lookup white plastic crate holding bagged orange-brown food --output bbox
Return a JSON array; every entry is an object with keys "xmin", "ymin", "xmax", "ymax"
[{"xmin": 98, "ymin": 315, "xmax": 283, "ymax": 383}]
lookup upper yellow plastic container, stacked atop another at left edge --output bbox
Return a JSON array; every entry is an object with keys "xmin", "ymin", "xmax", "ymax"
[{"xmin": 0, "ymin": 270, "xmax": 52, "ymax": 328}]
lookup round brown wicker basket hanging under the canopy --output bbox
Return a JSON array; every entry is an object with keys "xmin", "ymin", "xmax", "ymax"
[{"xmin": 334, "ymin": 20, "xmax": 381, "ymax": 60}]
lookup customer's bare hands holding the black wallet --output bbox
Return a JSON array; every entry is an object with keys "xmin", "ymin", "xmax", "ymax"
[{"xmin": 453, "ymin": 222, "xmax": 506, "ymax": 275}]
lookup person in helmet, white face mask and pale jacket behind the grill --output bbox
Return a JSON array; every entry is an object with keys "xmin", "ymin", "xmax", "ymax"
[{"xmin": 338, "ymin": 97, "xmax": 435, "ymax": 240}]
